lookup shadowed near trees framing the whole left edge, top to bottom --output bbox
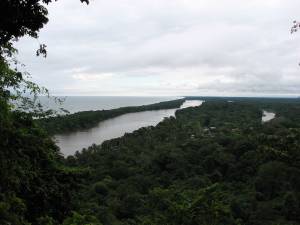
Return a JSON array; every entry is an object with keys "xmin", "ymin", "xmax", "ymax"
[{"xmin": 0, "ymin": 0, "xmax": 93, "ymax": 225}]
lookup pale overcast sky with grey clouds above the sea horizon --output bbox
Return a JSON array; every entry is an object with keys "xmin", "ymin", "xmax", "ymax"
[{"xmin": 17, "ymin": 0, "xmax": 300, "ymax": 96}]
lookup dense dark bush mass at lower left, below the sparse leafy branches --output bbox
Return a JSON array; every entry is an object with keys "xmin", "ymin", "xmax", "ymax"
[{"xmin": 0, "ymin": 103, "xmax": 85, "ymax": 224}]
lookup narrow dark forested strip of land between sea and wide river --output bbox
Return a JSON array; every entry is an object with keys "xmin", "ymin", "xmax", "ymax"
[{"xmin": 38, "ymin": 98, "xmax": 185, "ymax": 135}]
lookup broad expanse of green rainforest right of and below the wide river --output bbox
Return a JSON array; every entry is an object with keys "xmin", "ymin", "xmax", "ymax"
[{"xmin": 58, "ymin": 99, "xmax": 300, "ymax": 225}]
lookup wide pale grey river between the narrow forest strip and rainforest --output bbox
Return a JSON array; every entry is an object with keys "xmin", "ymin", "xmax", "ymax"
[{"xmin": 55, "ymin": 100, "xmax": 202, "ymax": 156}]
